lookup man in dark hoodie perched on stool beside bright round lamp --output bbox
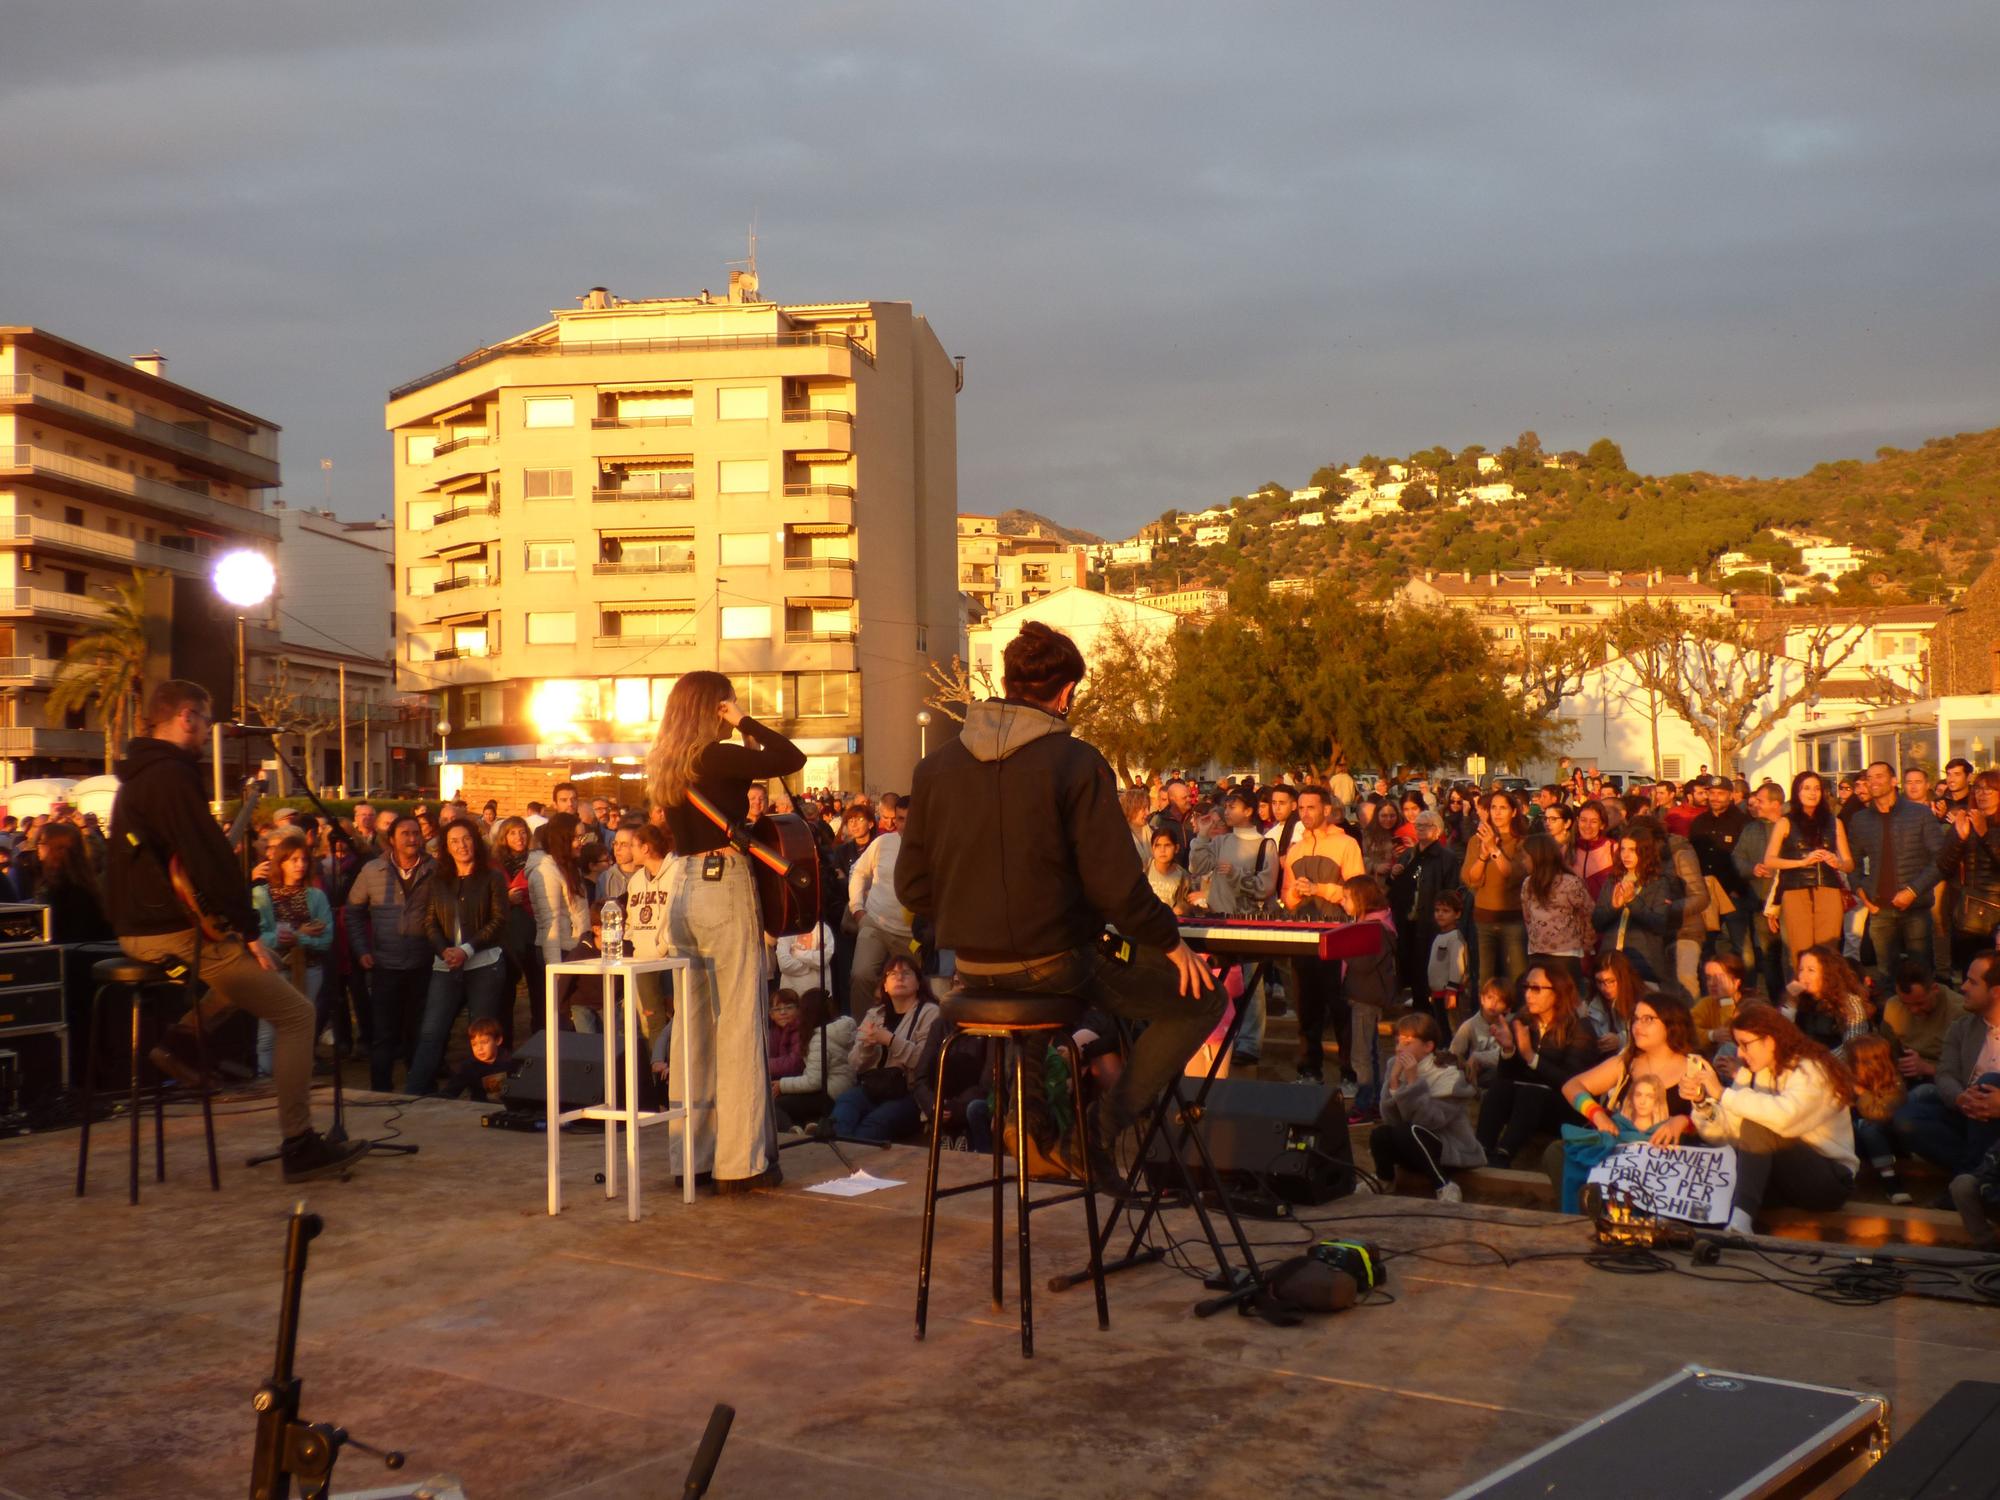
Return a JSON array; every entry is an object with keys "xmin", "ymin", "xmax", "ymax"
[{"xmin": 104, "ymin": 682, "xmax": 368, "ymax": 1182}]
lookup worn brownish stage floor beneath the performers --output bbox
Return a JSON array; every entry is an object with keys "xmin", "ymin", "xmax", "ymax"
[{"xmin": 0, "ymin": 1102, "xmax": 2000, "ymax": 1500}]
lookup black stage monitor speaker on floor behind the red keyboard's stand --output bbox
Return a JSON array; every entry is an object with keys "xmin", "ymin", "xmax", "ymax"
[{"xmin": 1182, "ymin": 1078, "xmax": 1354, "ymax": 1204}]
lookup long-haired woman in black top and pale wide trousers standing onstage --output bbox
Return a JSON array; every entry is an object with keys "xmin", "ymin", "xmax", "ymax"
[{"xmin": 646, "ymin": 672, "xmax": 806, "ymax": 1192}]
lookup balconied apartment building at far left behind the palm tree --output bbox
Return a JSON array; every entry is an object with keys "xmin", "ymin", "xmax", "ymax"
[{"xmin": 0, "ymin": 326, "xmax": 280, "ymax": 778}]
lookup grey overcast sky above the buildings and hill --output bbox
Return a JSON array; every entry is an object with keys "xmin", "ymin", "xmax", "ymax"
[{"xmin": 0, "ymin": 0, "xmax": 2000, "ymax": 534}]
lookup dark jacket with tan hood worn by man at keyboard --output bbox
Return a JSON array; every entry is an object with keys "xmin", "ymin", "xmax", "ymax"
[{"xmin": 896, "ymin": 698, "xmax": 1180, "ymax": 962}]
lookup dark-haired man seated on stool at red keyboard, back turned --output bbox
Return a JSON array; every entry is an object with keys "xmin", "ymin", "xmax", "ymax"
[{"xmin": 896, "ymin": 620, "xmax": 1222, "ymax": 1190}]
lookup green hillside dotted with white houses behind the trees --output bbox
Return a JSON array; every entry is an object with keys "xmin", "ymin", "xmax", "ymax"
[{"xmin": 1108, "ymin": 428, "xmax": 2000, "ymax": 604}]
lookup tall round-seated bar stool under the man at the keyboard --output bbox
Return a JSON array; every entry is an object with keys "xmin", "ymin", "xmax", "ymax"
[{"xmin": 916, "ymin": 990, "xmax": 1112, "ymax": 1360}]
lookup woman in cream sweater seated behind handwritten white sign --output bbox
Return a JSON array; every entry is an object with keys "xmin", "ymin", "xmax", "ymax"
[{"xmin": 1680, "ymin": 1006, "xmax": 1858, "ymax": 1234}]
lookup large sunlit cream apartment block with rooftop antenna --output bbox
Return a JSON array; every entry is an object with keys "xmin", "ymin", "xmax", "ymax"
[{"xmin": 386, "ymin": 272, "xmax": 962, "ymax": 804}]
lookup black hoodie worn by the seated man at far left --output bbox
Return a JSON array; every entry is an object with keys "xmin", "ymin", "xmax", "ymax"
[{"xmin": 104, "ymin": 736, "xmax": 258, "ymax": 940}]
